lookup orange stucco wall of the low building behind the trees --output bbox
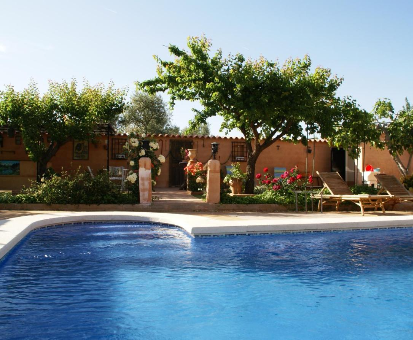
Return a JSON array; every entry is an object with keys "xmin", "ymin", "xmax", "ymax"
[{"xmin": 0, "ymin": 133, "xmax": 407, "ymax": 190}]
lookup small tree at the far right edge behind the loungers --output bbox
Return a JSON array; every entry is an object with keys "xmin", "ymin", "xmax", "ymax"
[{"xmin": 372, "ymin": 98, "xmax": 413, "ymax": 177}]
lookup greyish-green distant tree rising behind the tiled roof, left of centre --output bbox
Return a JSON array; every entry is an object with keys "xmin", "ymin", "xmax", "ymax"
[{"xmin": 118, "ymin": 91, "xmax": 179, "ymax": 135}]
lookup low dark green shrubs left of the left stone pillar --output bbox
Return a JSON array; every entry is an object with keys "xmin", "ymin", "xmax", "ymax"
[{"xmin": 0, "ymin": 171, "xmax": 139, "ymax": 204}]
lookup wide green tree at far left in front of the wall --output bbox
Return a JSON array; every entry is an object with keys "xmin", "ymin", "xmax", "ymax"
[{"xmin": 0, "ymin": 80, "xmax": 125, "ymax": 179}]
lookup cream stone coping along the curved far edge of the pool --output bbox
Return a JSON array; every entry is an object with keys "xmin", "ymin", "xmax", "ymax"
[{"xmin": 0, "ymin": 212, "xmax": 413, "ymax": 259}]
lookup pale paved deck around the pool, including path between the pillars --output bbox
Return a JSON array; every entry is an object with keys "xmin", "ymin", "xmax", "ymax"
[{"xmin": 0, "ymin": 189, "xmax": 413, "ymax": 258}]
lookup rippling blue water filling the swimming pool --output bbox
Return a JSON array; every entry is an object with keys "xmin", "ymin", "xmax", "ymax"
[{"xmin": 0, "ymin": 224, "xmax": 413, "ymax": 340}]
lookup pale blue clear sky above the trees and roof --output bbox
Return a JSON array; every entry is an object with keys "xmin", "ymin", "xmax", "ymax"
[{"xmin": 0, "ymin": 0, "xmax": 413, "ymax": 136}]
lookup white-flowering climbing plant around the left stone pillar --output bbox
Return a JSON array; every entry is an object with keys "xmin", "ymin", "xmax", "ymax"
[{"xmin": 125, "ymin": 135, "xmax": 165, "ymax": 194}]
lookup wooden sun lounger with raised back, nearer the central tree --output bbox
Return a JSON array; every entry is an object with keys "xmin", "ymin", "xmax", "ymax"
[{"xmin": 313, "ymin": 171, "xmax": 391, "ymax": 215}]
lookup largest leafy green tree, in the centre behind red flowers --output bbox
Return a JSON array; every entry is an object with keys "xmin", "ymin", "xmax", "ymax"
[{"xmin": 137, "ymin": 37, "xmax": 358, "ymax": 193}]
